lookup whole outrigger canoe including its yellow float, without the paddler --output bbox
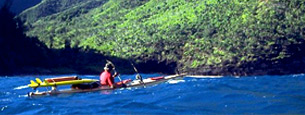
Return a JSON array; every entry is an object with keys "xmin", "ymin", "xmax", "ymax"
[{"xmin": 28, "ymin": 75, "xmax": 185, "ymax": 97}]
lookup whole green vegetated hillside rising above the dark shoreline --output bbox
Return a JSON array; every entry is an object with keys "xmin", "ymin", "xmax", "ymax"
[{"xmin": 13, "ymin": 0, "xmax": 305, "ymax": 75}]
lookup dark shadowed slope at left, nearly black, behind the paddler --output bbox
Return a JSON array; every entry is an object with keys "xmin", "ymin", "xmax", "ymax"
[{"xmin": 0, "ymin": 0, "xmax": 131, "ymax": 75}]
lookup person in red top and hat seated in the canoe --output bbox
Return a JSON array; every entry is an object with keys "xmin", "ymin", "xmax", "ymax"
[{"xmin": 100, "ymin": 63, "xmax": 119, "ymax": 88}]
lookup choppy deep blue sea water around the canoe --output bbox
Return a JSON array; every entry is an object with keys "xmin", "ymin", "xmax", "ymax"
[{"xmin": 0, "ymin": 74, "xmax": 305, "ymax": 115}]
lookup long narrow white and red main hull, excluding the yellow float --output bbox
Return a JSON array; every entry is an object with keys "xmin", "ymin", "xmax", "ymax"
[{"xmin": 28, "ymin": 75, "xmax": 185, "ymax": 97}]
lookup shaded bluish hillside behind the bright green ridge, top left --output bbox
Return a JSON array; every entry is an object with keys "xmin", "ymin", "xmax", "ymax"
[{"xmin": 19, "ymin": 0, "xmax": 104, "ymax": 23}]
